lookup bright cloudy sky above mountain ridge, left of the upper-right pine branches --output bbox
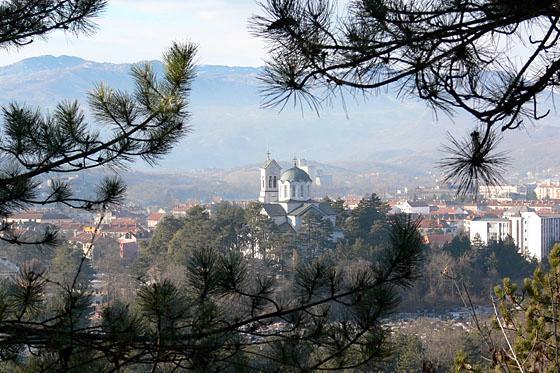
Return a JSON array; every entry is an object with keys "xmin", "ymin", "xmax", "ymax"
[{"xmin": 0, "ymin": 0, "xmax": 265, "ymax": 66}]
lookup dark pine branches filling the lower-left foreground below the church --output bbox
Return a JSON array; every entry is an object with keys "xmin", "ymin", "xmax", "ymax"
[{"xmin": 0, "ymin": 213, "xmax": 422, "ymax": 371}]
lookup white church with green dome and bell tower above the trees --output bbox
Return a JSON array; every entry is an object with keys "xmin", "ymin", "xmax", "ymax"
[{"xmin": 259, "ymin": 153, "xmax": 336, "ymax": 231}]
